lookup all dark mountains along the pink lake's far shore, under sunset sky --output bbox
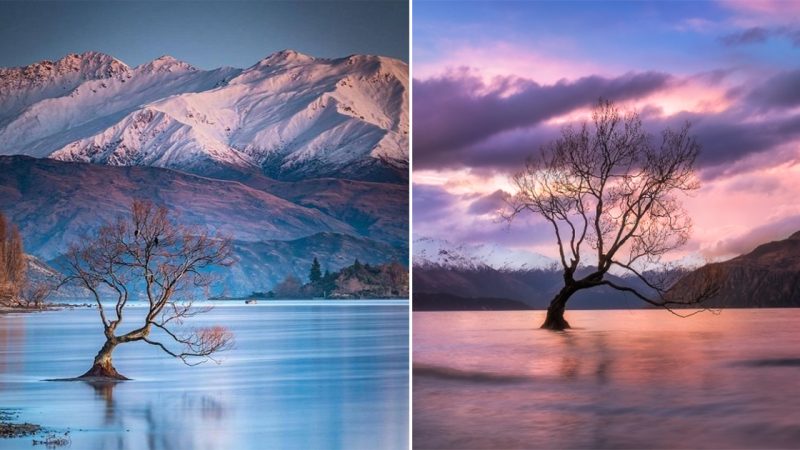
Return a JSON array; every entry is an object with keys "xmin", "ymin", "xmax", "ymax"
[{"xmin": 413, "ymin": 231, "xmax": 800, "ymax": 310}]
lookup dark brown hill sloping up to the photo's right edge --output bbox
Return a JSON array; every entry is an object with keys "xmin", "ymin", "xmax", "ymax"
[{"xmin": 670, "ymin": 232, "xmax": 800, "ymax": 308}]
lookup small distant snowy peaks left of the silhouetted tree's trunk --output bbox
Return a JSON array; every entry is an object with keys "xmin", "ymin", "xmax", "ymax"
[{"xmin": 414, "ymin": 238, "xmax": 556, "ymax": 271}]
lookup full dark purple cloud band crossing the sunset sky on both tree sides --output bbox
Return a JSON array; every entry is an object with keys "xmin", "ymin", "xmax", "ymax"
[{"xmin": 414, "ymin": 69, "xmax": 800, "ymax": 179}]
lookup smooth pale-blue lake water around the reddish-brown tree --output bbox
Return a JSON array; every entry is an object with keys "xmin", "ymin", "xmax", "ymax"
[{"xmin": 0, "ymin": 301, "xmax": 409, "ymax": 450}]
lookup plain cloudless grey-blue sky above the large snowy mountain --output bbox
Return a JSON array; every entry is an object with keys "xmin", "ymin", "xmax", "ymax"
[{"xmin": 0, "ymin": 0, "xmax": 409, "ymax": 69}]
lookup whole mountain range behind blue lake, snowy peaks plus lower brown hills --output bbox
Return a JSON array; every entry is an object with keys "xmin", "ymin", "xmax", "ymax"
[{"xmin": 0, "ymin": 50, "xmax": 409, "ymax": 295}]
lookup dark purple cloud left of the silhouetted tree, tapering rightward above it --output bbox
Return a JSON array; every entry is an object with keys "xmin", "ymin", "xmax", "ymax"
[{"xmin": 413, "ymin": 70, "xmax": 672, "ymax": 168}]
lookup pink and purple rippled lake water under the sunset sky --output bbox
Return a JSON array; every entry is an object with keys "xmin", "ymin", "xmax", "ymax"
[{"xmin": 413, "ymin": 309, "xmax": 800, "ymax": 449}]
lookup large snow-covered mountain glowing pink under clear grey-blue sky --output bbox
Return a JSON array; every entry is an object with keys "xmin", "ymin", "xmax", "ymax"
[{"xmin": 0, "ymin": 50, "xmax": 409, "ymax": 180}]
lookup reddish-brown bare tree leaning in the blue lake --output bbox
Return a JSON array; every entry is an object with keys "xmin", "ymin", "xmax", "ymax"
[{"xmin": 62, "ymin": 201, "xmax": 232, "ymax": 380}]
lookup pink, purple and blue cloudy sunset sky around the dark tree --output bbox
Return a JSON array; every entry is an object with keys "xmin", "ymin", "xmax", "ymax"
[{"xmin": 412, "ymin": 0, "xmax": 800, "ymax": 263}]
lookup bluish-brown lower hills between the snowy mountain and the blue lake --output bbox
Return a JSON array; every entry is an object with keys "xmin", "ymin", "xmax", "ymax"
[{"xmin": 0, "ymin": 156, "xmax": 408, "ymax": 295}]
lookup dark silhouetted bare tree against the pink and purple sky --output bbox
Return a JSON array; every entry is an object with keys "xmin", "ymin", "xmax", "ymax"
[{"xmin": 505, "ymin": 100, "xmax": 719, "ymax": 330}]
